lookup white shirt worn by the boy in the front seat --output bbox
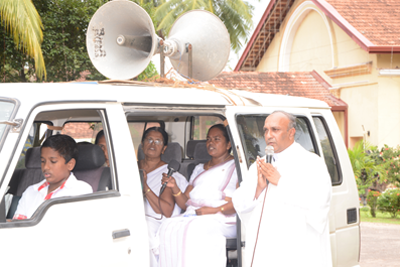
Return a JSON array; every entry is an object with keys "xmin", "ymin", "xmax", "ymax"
[{"xmin": 15, "ymin": 172, "xmax": 93, "ymax": 219}]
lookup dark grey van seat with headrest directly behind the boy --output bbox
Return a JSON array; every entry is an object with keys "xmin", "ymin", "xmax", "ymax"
[{"xmin": 73, "ymin": 143, "xmax": 112, "ymax": 192}]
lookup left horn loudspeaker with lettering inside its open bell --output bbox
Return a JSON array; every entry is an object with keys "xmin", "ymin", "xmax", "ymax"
[{"xmin": 86, "ymin": 0, "xmax": 158, "ymax": 80}]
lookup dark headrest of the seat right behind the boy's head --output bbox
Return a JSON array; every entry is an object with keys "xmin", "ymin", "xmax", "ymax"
[{"xmin": 74, "ymin": 144, "xmax": 106, "ymax": 171}]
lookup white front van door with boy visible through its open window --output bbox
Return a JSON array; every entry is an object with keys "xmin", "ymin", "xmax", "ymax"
[{"xmin": 0, "ymin": 103, "xmax": 149, "ymax": 266}]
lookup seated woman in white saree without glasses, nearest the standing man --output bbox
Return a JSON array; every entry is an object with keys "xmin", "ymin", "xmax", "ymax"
[{"xmin": 159, "ymin": 124, "xmax": 238, "ymax": 267}]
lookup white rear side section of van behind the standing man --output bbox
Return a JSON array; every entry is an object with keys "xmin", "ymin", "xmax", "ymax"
[{"xmin": 226, "ymin": 107, "xmax": 359, "ymax": 266}]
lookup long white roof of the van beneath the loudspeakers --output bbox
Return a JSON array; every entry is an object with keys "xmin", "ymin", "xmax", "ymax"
[{"xmin": 0, "ymin": 82, "xmax": 329, "ymax": 108}]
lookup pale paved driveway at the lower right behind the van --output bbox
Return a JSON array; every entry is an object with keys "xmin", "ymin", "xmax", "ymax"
[{"xmin": 360, "ymin": 222, "xmax": 400, "ymax": 267}]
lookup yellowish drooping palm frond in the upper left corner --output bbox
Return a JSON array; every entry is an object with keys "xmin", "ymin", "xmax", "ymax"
[{"xmin": 0, "ymin": 0, "xmax": 46, "ymax": 79}]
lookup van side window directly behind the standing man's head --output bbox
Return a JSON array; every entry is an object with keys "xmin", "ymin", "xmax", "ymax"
[{"xmin": 236, "ymin": 115, "xmax": 319, "ymax": 166}]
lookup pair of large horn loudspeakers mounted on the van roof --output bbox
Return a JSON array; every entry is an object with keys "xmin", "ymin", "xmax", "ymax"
[{"xmin": 86, "ymin": 0, "xmax": 230, "ymax": 81}]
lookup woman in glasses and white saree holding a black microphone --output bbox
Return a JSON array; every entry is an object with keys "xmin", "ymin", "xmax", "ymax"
[{"xmin": 138, "ymin": 127, "xmax": 188, "ymax": 267}]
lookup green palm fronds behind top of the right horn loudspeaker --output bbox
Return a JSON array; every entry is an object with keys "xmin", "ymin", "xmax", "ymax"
[{"xmin": 152, "ymin": 0, "xmax": 253, "ymax": 52}]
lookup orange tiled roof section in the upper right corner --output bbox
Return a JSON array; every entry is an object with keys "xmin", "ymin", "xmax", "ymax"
[{"xmin": 326, "ymin": 0, "xmax": 400, "ymax": 46}]
